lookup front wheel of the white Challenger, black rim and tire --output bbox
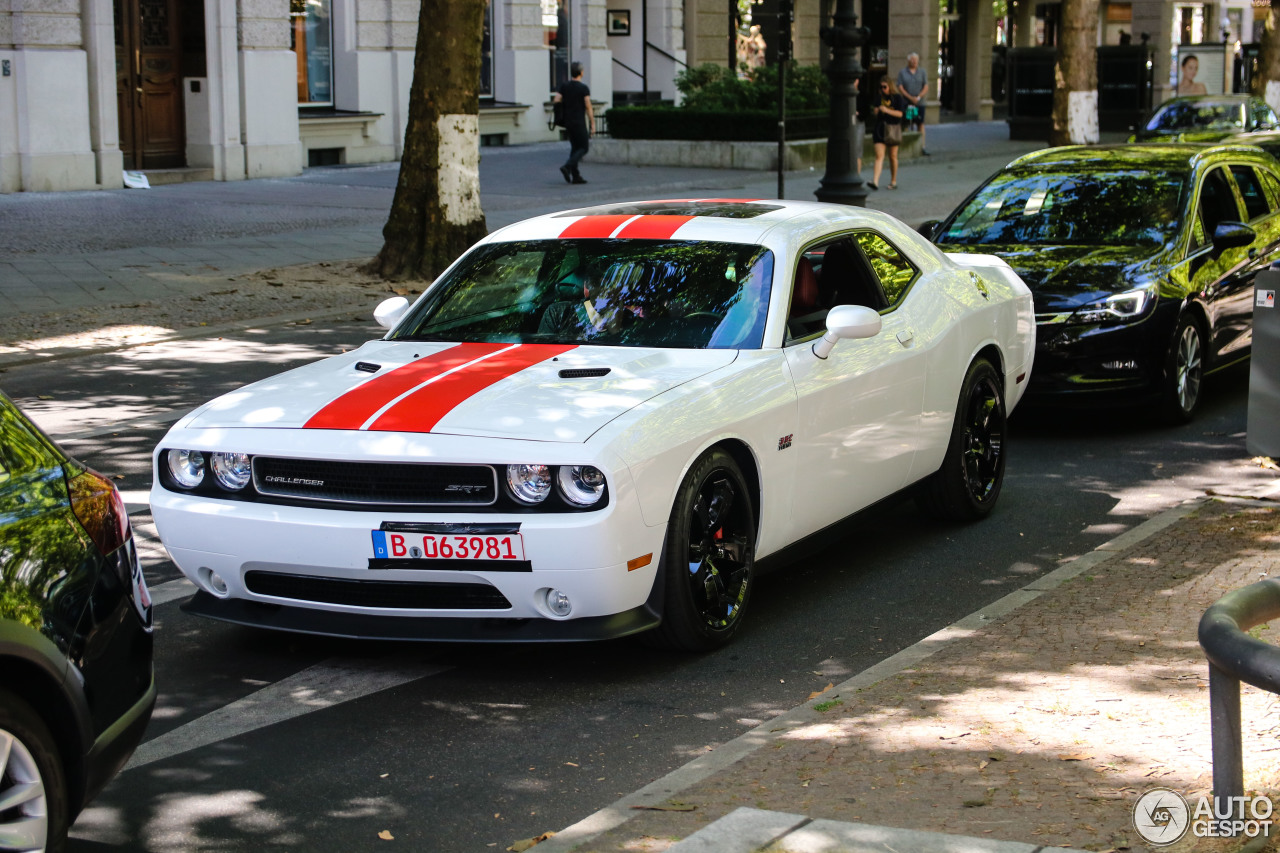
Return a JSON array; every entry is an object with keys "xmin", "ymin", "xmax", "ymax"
[{"xmin": 645, "ymin": 450, "xmax": 755, "ymax": 652}]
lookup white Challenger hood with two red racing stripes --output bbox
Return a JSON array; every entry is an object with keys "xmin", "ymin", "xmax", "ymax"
[{"xmin": 180, "ymin": 341, "xmax": 737, "ymax": 442}]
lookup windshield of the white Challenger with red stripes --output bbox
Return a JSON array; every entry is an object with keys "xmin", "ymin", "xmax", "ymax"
[{"xmin": 388, "ymin": 240, "xmax": 773, "ymax": 350}]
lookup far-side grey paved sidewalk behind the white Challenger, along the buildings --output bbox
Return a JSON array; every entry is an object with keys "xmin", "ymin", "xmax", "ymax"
[{"xmin": 0, "ymin": 122, "xmax": 1039, "ymax": 364}]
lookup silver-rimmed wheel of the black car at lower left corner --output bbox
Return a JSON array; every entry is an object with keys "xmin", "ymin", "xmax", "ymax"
[{"xmin": 0, "ymin": 690, "xmax": 69, "ymax": 853}]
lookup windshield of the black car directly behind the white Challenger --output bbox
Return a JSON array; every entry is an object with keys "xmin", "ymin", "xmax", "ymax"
[{"xmin": 937, "ymin": 169, "xmax": 1185, "ymax": 246}]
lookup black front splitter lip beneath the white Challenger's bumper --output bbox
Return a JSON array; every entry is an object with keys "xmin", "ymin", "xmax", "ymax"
[{"xmin": 182, "ymin": 592, "xmax": 660, "ymax": 643}]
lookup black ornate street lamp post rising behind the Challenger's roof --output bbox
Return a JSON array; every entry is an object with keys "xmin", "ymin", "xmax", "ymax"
[{"xmin": 814, "ymin": 0, "xmax": 870, "ymax": 207}]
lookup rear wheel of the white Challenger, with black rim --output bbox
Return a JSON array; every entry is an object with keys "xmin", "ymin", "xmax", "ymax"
[{"xmin": 919, "ymin": 359, "xmax": 1009, "ymax": 521}]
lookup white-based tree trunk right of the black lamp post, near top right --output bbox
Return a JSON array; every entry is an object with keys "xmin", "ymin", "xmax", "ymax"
[{"xmin": 1048, "ymin": 0, "xmax": 1098, "ymax": 145}]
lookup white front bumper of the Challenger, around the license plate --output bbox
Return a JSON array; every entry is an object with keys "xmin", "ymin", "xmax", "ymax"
[{"xmin": 151, "ymin": 473, "xmax": 666, "ymax": 627}]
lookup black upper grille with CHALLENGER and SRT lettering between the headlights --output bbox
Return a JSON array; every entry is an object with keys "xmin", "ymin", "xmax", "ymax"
[{"xmin": 253, "ymin": 456, "xmax": 498, "ymax": 506}]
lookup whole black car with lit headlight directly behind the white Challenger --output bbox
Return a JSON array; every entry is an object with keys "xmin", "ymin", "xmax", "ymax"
[{"xmin": 928, "ymin": 143, "xmax": 1280, "ymax": 421}]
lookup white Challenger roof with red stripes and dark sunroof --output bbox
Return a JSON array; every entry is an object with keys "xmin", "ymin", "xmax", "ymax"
[{"xmin": 485, "ymin": 199, "xmax": 906, "ymax": 243}]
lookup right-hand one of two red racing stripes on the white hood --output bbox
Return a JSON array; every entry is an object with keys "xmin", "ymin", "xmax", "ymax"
[{"xmin": 369, "ymin": 343, "xmax": 576, "ymax": 433}]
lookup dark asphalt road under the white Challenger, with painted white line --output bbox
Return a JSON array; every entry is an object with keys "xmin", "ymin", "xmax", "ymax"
[{"xmin": 4, "ymin": 321, "xmax": 1267, "ymax": 853}]
